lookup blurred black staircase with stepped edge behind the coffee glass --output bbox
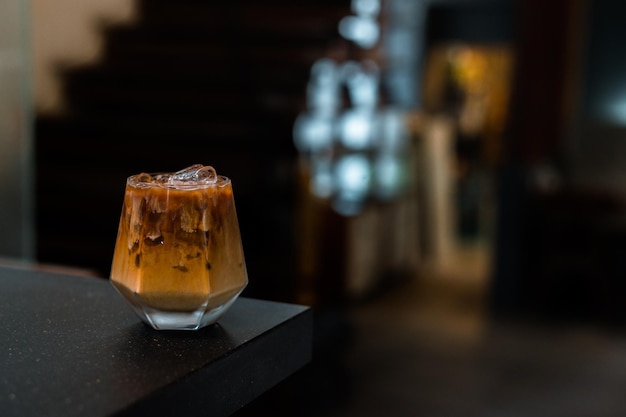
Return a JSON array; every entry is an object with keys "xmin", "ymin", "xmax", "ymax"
[{"xmin": 35, "ymin": 0, "xmax": 350, "ymax": 299}]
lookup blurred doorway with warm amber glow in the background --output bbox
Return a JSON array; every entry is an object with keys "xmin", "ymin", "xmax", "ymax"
[{"xmin": 421, "ymin": 1, "xmax": 515, "ymax": 286}]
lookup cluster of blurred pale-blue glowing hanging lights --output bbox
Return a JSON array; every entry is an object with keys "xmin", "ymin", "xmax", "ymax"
[{"xmin": 293, "ymin": 0, "xmax": 414, "ymax": 216}]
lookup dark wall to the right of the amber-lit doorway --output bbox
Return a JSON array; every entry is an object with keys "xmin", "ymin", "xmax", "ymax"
[{"xmin": 491, "ymin": 0, "xmax": 626, "ymax": 324}]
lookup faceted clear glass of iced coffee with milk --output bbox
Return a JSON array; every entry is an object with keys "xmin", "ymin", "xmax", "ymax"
[{"xmin": 111, "ymin": 165, "xmax": 248, "ymax": 330}]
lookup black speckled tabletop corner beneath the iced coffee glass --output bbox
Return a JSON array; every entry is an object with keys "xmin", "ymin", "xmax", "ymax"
[{"xmin": 0, "ymin": 266, "xmax": 313, "ymax": 417}]
